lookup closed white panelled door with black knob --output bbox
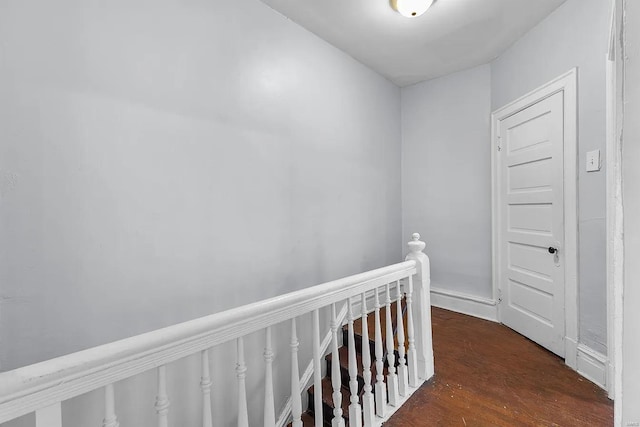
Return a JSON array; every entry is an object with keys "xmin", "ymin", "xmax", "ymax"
[{"xmin": 497, "ymin": 92, "xmax": 565, "ymax": 357}]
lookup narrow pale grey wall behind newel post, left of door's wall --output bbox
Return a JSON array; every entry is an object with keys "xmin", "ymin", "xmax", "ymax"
[{"xmin": 402, "ymin": 65, "xmax": 492, "ymax": 298}]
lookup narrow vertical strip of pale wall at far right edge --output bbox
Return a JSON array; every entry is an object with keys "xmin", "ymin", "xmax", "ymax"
[{"xmin": 620, "ymin": 1, "xmax": 640, "ymax": 426}]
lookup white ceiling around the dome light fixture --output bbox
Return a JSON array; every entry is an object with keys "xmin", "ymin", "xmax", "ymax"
[{"xmin": 262, "ymin": 0, "xmax": 565, "ymax": 86}]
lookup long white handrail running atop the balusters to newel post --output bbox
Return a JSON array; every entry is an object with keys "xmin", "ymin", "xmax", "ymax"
[{"xmin": 0, "ymin": 260, "xmax": 417, "ymax": 424}]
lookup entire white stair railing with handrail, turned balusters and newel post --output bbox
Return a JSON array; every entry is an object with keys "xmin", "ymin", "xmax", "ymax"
[{"xmin": 0, "ymin": 234, "xmax": 434, "ymax": 427}]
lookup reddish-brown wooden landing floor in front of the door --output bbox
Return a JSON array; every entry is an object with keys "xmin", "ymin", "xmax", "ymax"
[{"xmin": 385, "ymin": 308, "xmax": 613, "ymax": 427}]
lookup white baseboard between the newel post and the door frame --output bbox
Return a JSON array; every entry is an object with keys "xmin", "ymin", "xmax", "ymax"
[{"xmin": 431, "ymin": 286, "xmax": 498, "ymax": 322}]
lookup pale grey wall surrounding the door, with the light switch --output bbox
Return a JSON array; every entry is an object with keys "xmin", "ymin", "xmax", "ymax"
[{"xmin": 491, "ymin": 0, "xmax": 611, "ymax": 354}]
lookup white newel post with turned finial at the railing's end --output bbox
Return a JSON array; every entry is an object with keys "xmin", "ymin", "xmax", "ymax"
[{"xmin": 406, "ymin": 233, "xmax": 435, "ymax": 379}]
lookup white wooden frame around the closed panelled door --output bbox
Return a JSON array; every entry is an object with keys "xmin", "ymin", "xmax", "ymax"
[{"xmin": 491, "ymin": 68, "xmax": 578, "ymax": 370}]
